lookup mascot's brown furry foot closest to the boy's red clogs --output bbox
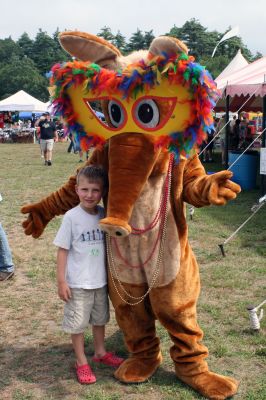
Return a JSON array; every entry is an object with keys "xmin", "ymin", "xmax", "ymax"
[{"xmin": 114, "ymin": 353, "xmax": 163, "ymax": 383}]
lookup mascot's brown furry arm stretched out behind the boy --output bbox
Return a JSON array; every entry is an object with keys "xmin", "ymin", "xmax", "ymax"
[{"xmin": 21, "ymin": 145, "xmax": 106, "ymax": 238}]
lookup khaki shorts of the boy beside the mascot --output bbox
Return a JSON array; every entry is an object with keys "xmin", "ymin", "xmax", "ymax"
[{"xmin": 62, "ymin": 286, "xmax": 110, "ymax": 334}]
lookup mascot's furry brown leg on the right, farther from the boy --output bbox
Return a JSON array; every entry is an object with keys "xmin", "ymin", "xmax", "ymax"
[{"xmin": 150, "ymin": 255, "xmax": 238, "ymax": 400}]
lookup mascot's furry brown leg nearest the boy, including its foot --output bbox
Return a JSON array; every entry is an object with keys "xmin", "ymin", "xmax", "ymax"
[{"xmin": 109, "ymin": 279, "xmax": 162, "ymax": 383}]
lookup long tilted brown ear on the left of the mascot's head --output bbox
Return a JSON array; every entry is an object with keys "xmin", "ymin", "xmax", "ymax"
[{"xmin": 59, "ymin": 31, "xmax": 121, "ymax": 69}]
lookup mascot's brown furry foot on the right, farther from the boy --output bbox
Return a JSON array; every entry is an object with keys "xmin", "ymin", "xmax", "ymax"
[{"xmin": 178, "ymin": 371, "xmax": 239, "ymax": 400}]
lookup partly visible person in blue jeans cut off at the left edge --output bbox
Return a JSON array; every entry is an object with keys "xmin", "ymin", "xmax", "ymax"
[{"xmin": 0, "ymin": 194, "xmax": 14, "ymax": 282}]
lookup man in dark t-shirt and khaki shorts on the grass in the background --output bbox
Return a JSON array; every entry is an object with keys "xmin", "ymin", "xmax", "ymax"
[{"xmin": 36, "ymin": 112, "xmax": 57, "ymax": 166}]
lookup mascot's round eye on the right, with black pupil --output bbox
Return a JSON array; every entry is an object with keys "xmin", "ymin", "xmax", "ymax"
[{"xmin": 135, "ymin": 99, "xmax": 160, "ymax": 128}]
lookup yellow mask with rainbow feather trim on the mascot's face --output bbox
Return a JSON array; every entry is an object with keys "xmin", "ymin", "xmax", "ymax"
[{"xmin": 51, "ymin": 33, "xmax": 218, "ymax": 159}]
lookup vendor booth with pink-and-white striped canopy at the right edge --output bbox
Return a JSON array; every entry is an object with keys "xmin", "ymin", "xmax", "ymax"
[{"xmin": 215, "ymin": 57, "xmax": 266, "ymax": 193}]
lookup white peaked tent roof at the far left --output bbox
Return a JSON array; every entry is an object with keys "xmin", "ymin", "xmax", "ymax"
[{"xmin": 0, "ymin": 90, "xmax": 47, "ymax": 112}]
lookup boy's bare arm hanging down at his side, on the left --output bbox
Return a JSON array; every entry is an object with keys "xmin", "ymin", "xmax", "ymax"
[{"xmin": 56, "ymin": 247, "xmax": 71, "ymax": 301}]
